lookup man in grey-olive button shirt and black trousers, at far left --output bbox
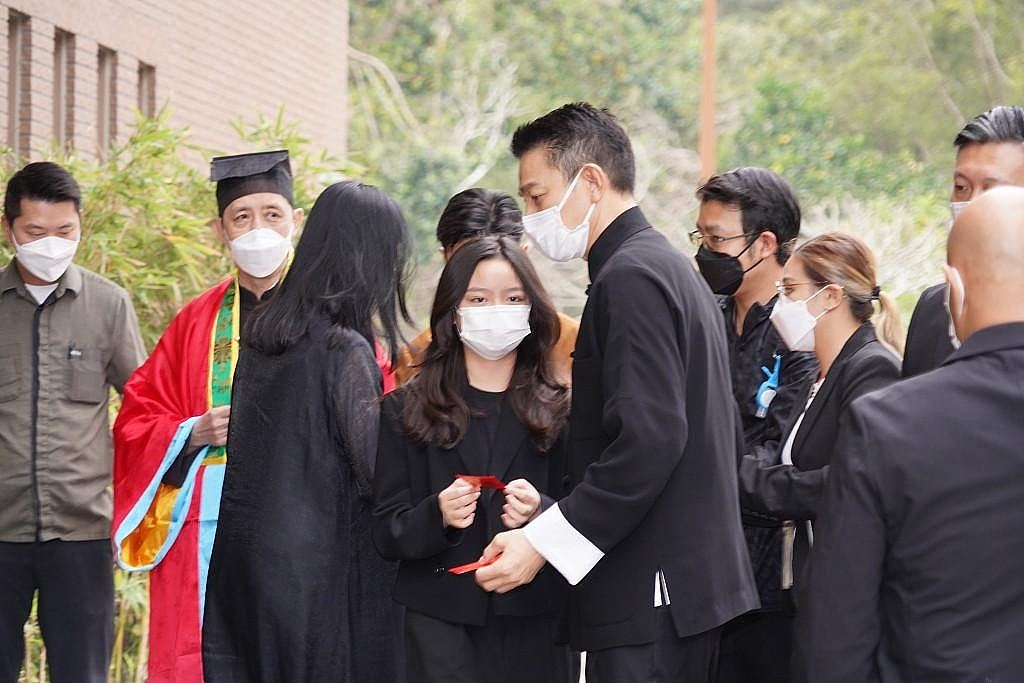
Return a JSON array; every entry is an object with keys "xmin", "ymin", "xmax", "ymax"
[{"xmin": 0, "ymin": 162, "xmax": 145, "ymax": 683}]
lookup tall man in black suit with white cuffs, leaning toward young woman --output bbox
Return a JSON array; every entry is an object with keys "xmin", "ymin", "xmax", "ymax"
[{"xmin": 476, "ymin": 103, "xmax": 758, "ymax": 683}]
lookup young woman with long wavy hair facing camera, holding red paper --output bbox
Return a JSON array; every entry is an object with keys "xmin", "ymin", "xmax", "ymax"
[{"xmin": 374, "ymin": 223, "xmax": 569, "ymax": 683}]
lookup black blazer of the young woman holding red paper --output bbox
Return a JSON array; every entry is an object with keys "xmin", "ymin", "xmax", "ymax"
[{"xmin": 374, "ymin": 389, "xmax": 567, "ymax": 625}]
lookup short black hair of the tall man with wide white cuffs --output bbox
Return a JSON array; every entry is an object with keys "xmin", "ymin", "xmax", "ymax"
[{"xmin": 511, "ymin": 102, "xmax": 636, "ymax": 194}]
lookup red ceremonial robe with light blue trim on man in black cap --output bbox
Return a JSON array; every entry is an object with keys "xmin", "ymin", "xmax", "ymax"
[{"xmin": 113, "ymin": 279, "xmax": 394, "ymax": 683}]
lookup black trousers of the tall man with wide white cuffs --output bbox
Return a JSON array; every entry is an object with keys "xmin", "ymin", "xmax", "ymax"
[{"xmin": 587, "ymin": 607, "xmax": 721, "ymax": 683}]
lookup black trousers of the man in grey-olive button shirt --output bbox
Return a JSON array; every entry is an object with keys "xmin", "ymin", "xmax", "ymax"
[{"xmin": 0, "ymin": 541, "xmax": 114, "ymax": 683}]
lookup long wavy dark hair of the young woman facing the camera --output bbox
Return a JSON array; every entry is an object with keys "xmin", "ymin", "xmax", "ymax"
[{"xmin": 398, "ymin": 237, "xmax": 569, "ymax": 451}]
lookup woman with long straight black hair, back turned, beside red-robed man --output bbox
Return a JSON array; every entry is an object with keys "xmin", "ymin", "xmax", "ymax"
[{"xmin": 201, "ymin": 182, "xmax": 410, "ymax": 683}]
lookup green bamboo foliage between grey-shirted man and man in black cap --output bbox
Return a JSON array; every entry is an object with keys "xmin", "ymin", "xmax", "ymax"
[{"xmin": 0, "ymin": 111, "xmax": 227, "ymax": 346}]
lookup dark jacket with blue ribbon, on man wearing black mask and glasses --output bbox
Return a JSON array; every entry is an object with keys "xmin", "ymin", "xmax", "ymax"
[{"xmin": 719, "ymin": 296, "xmax": 818, "ymax": 611}]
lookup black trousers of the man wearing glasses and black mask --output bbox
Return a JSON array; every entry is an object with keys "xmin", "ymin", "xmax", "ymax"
[{"xmin": 718, "ymin": 611, "xmax": 794, "ymax": 683}]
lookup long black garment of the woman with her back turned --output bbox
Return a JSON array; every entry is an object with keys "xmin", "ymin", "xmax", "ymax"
[{"xmin": 200, "ymin": 319, "xmax": 401, "ymax": 683}]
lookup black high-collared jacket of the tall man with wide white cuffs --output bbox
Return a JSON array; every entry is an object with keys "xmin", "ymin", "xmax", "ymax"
[{"xmin": 558, "ymin": 208, "xmax": 758, "ymax": 649}]
